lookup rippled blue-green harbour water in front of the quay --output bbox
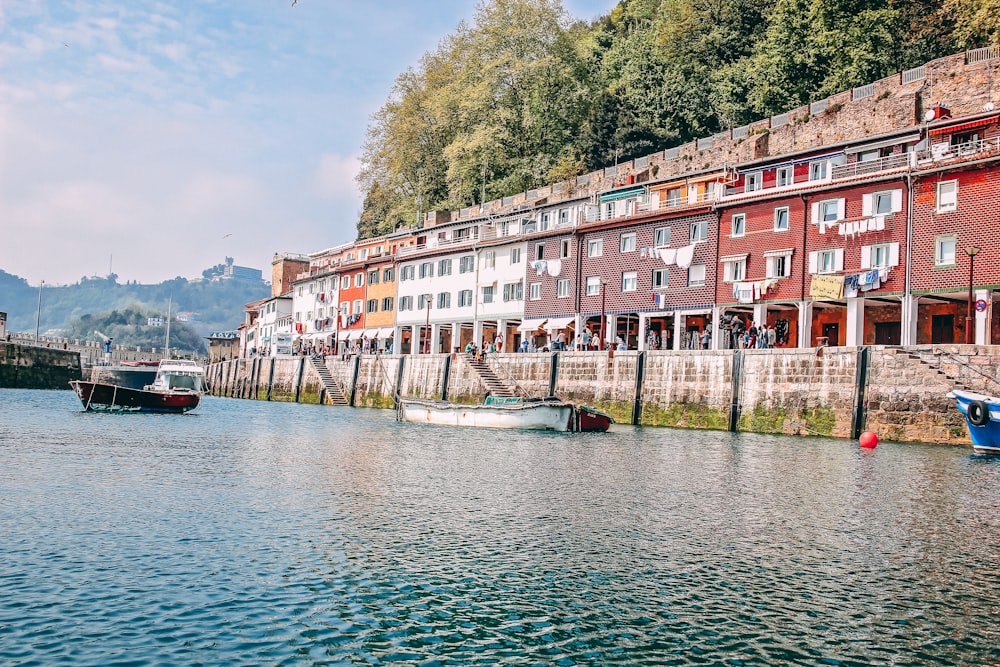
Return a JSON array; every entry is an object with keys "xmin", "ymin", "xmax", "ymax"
[{"xmin": 0, "ymin": 390, "xmax": 1000, "ymax": 665}]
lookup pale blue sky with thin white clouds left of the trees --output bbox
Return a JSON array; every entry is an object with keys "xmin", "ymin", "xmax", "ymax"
[{"xmin": 0, "ymin": 0, "xmax": 617, "ymax": 284}]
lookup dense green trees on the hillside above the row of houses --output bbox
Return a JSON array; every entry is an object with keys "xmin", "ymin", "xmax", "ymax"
[{"xmin": 358, "ymin": 0, "xmax": 1000, "ymax": 238}]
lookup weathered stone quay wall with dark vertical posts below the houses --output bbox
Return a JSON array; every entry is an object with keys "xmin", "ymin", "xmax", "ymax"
[{"xmin": 201, "ymin": 345, "xmax": 1000, "ymax": 444}]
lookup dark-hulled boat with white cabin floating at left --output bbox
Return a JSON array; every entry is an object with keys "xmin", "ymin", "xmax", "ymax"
[{"xmin": 69, "ymin": 359, "xmax": 205, "ymax": 413}]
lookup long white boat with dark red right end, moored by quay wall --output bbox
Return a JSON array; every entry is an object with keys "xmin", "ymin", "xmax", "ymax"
[{"xmin": 397, "ymin": 396, "xmax": 614, "ymax": 431}]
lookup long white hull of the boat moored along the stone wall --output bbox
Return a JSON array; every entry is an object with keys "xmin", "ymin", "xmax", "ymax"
[{"xmin": 399, "ymin": 399, "xmax": 574, "ymax": 431}]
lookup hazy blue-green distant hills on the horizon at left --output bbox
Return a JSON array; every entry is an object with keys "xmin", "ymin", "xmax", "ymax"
[{"xmin": 0, "ymin": 269, "xmax": 271, "ymax": 347}]
